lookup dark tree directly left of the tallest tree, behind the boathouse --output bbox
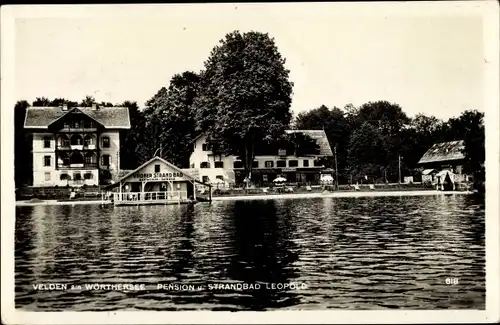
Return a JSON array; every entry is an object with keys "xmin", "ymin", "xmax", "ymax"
[{"xmin": 145, "ymin": 71, "xmax": 199, "ymax": 167}]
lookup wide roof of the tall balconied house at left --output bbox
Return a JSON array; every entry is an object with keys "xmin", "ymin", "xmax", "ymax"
[{"xmin": 24, "ymin": 107, "xmax": 130, "ymax": 129}]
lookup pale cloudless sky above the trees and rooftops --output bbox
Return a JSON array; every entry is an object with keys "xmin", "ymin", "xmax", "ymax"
[{"xmin": 15, "ymin": 3, "xmax": 485, "ymax": 119}]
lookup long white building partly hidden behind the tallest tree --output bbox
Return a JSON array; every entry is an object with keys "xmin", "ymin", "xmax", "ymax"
[{"xmin": 189, "ymin": 130, "xmax": 333, "ymax": 184}]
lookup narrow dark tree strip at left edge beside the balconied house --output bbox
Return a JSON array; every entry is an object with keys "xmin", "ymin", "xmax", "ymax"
[{"xmin": 14, "ymin": 100, "xmax": 33, "ymax": 187}]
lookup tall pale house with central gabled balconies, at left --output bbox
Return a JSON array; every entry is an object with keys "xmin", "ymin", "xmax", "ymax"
[{"xmin": 24, "ymin": 105, "xmax": 130, "ymax": 187}]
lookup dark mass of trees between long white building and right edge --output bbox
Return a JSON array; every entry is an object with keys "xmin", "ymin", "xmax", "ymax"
[{"xmin": 294, "ymin": 101, "xmax": 485, "ymax": 183}]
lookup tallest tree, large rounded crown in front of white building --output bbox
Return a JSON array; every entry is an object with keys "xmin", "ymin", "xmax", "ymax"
[{"xmin": 195, "ymin": 31, "xmax": 293, "ymax": 180}]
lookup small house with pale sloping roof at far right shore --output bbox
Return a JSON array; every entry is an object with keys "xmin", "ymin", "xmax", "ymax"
[{"xmin": 418, "ymin": 140, "xmax": 471, "ymax": 184}]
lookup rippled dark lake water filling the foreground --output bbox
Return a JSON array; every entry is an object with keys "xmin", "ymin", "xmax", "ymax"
[{"xmin": 15, "ymin": 194, "xmax": 485, "ymax": 311}]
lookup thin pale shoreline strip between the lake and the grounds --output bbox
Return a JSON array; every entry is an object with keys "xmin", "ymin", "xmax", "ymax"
[{"xmin": 16, "ymin": 190, "xmax": 473, "ymax": 207}]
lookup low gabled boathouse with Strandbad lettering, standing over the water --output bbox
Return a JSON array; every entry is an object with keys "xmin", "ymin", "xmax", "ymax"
[{"xmin": 108, "ymin": 157, "xmax": 211, "ymax": 205}]
